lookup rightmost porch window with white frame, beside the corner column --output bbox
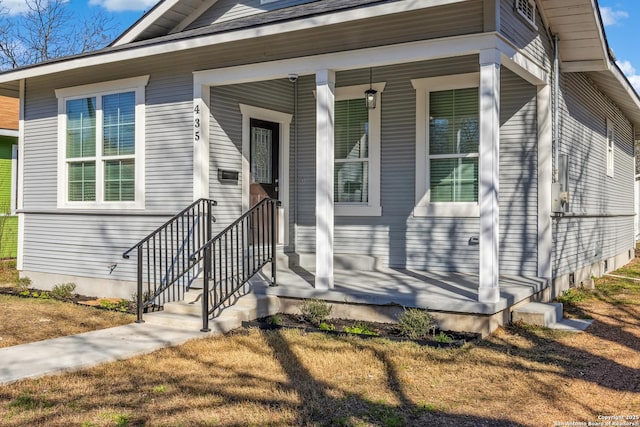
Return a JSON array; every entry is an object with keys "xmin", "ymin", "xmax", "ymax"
[{"xmin": 412, "ymin": 73, "xmax": 480, "ymax": 217}]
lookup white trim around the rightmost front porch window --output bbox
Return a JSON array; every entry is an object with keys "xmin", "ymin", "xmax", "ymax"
[{"xmin": 411, "ymin": 73, "xmax": 480, "ymax": 218}]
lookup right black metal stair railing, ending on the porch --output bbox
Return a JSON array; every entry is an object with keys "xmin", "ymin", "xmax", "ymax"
[{"xmin": 190, "ymin": 199, "xmax": 280, "ymax": 332}]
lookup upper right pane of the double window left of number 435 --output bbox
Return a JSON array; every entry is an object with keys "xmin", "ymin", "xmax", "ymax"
[{"xmin": 102, "ymin": 92, "xmax": 135, "ymax": 156}]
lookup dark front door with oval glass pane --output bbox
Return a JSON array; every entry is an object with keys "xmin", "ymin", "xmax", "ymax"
[{"xmin": 249, "ymin": 119, "xmax": 280, "ymax": 243}]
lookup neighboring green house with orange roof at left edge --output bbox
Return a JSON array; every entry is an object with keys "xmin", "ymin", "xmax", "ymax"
[{"xmin": 0, "ymin": 96, "xmax": 18, "ymax": 259}]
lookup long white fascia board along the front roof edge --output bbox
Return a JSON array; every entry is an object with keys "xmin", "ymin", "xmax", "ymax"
[{"xmin": 0, "ymin": 0, "xmax": 464, "ymax": 84}]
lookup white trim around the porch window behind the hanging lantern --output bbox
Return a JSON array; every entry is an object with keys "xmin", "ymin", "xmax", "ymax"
[{"xmin": 334, "ymin": 82, "xmax": 387, "ymax": 216}]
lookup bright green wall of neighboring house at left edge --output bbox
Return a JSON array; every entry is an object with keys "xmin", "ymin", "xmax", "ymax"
[{"xmin": 0, "ymin": 136, "xmax": 18, "ymax": 259}]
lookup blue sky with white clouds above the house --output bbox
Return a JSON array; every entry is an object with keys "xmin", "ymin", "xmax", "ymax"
[{"xmin": 0, "ymin": 0, "xmax": 640, "ymax": 93}]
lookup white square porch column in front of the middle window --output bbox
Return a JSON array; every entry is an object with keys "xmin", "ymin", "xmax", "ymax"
[{"xmin": 315, "ymin": 70, "xmax": 336, "ymax": 289}]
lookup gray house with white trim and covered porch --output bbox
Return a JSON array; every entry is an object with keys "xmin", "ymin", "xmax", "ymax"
[{"xmin": 0, "ymin": 0, "xmax": 640, "ymax": 334}]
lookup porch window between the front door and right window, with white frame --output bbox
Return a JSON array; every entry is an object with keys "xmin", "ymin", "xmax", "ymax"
[{"xmin": 334, "ymin": 83, "xmax": 385, "ymax": 216}]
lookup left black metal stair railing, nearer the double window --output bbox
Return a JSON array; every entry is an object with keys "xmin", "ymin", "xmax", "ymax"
[{"xmin": 122, "ymin": 199, "xmax": 216, "ymax": 323}]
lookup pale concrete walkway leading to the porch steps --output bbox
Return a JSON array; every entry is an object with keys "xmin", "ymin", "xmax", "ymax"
[{"xmin": 0, "ymin": 323, "xmax": 207, "ymax": 385}]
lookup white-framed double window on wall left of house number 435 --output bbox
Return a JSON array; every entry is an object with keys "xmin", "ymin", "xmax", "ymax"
[{"xmin": 56, "ymin": 76, "xmax": 148, "ymax": 209}]
